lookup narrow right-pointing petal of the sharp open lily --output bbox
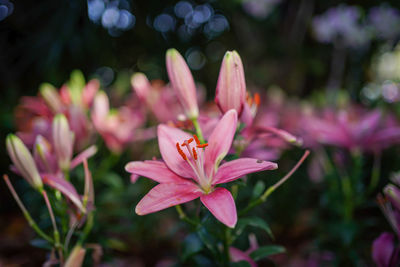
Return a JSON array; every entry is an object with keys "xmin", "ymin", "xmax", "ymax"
[{"xmin": 213, "ymin": 158, "xmax": 278, "ymax": 185}]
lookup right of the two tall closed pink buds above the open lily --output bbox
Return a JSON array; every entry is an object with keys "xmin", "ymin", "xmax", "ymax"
[{"xmin": 215, "ymin": 51, "xmax": 246, "ymax": 115}]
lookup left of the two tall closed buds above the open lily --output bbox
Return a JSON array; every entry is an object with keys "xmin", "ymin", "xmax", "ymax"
[{"xmin": 166, "ymin": 49, "xmax": 199, "ymax": 119}]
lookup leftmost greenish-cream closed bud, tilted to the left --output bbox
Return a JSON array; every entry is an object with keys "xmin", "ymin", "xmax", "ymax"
[{"xmin": 6, "ymin": 134, "xmax": 43, "ymax": 190}]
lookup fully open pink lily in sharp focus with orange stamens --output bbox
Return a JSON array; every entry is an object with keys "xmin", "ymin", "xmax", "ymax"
[{"xmin": 125, "ymin": 110, "xmax": 277, "ymax": 228}]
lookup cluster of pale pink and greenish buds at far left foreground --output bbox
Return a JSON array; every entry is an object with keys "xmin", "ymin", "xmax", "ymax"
[{"xmin": 6, "ymin": 114, "xmax": 97, "ymax": 213}]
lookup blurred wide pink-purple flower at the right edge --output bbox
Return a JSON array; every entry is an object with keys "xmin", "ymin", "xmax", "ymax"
[{"xmin": 302, "ymin": 106, "xmax": 400, "ymax": 152}]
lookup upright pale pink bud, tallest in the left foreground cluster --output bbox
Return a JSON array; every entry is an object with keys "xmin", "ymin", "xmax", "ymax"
[{"xmin": 52, "ymin": 114, "xmax": 74, "ymax": 170}]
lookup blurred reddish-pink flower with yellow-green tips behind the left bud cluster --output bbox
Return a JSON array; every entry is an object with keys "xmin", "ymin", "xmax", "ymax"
[{"xmin": 15, "ymin": 76, "xmax": 100, "ymax": 149}]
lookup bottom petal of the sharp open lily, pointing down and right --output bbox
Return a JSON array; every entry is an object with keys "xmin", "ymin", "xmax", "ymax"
[{"xmin": 200, "ymin": 187, "xmax": 237, "ymax": 228}]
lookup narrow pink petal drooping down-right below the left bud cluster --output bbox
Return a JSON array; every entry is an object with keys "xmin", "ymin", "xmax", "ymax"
[{"xmin": 42, "ymin": 174, "xmax": 86, "ymax": 212}]
